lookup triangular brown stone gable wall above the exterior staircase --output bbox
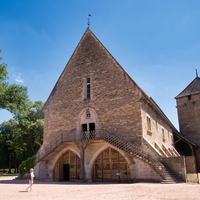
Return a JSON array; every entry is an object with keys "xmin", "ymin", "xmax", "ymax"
[{"xmin": 43, "ymin": 28, "xmax": 145, "ymax": 145}]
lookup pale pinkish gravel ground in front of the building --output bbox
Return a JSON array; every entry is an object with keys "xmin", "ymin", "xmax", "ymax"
[{"xmin": 0, "ymin": 177, "xmax": 200, "ymax": 200}]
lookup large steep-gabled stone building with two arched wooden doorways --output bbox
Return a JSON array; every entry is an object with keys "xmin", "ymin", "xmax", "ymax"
[{"xmin": 34, "ymin": 28, "xmax": 184, "ymax": 182}]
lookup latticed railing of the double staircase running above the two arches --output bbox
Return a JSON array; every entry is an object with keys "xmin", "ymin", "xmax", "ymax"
[{"xmin": 35, "ymin": 129, "xmax": 165, "ymax": 179}]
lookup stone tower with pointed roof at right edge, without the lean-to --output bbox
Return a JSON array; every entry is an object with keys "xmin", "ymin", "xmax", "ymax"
[{"xmin": 175, "ymin": 75, "xmax": 200, "ymax": 171}]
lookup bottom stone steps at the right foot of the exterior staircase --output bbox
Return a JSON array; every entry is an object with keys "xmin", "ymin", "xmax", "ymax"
[{"xmin": 161, "ymin": 166, "xmax": 185, "ymax": 184}]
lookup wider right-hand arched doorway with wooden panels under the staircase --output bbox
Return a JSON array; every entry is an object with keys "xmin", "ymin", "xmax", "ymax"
[{"xmin": 92, "ymin": 148, "xmax": 130, "ymax": 182}]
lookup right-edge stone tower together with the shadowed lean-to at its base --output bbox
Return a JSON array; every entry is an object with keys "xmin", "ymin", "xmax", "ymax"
[{"xmin": 175, "ymin": 74, "xmax": 200, "ymax": 177}]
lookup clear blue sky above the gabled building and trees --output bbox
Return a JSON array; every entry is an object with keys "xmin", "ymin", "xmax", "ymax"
[{"xmin": 0, "ymin": 0, "xmax": 200, "ymax": 129}]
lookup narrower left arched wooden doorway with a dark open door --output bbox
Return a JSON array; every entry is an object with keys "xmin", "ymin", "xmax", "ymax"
[{"xmin": 54, "ymin": 150, "xmax": 80, "ymax": 181}]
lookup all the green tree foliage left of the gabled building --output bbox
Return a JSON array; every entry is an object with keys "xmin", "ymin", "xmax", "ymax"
[{"xmin": 0, "ymin": 51, "xmax": 44, "ymax": 171}]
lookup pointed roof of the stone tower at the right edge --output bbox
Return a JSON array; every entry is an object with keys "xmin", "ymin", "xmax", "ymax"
[{"xmin": 175, "ymin": 76, "xmax": 200, "ymax": 99}]
